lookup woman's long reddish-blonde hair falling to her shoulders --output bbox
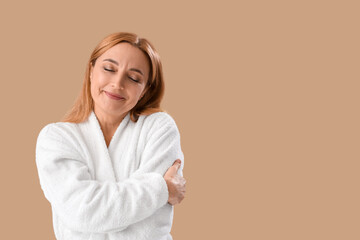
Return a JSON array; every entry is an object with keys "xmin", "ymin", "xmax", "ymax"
[{"xmin": 62, "ymin": 32, "xmax": 165, "ymax": 123}]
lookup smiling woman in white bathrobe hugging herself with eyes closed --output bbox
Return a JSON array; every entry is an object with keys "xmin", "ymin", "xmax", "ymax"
[{"xmin": 36, "ymin": 33, "xmax": 185, "ymax": 240}]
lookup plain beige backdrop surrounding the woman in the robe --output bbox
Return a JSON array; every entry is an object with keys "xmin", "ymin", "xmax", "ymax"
[{"xmin": 0, "ymin": 0, "xmax": 360, "ymax": 240}]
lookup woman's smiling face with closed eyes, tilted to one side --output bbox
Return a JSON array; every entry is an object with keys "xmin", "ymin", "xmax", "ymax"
[{"xmin": 90, "ymin": 43, "xmax": 150, "ymax": 120}]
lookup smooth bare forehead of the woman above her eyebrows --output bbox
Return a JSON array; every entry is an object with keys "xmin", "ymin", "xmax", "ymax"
[{"xmin": 99, "ymin": 42, "xmax": 149, "ymax": 72}]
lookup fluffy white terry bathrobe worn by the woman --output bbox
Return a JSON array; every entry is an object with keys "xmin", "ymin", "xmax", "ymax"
[{"xmin": 36, "ymin": 112, "xmax": 184, "ymax": 240}]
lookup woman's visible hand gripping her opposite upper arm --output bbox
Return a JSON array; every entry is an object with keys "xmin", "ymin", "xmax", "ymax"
[{"xmin": 164, "ymin": 159, "xmax": 186, "ymax": 205}]
